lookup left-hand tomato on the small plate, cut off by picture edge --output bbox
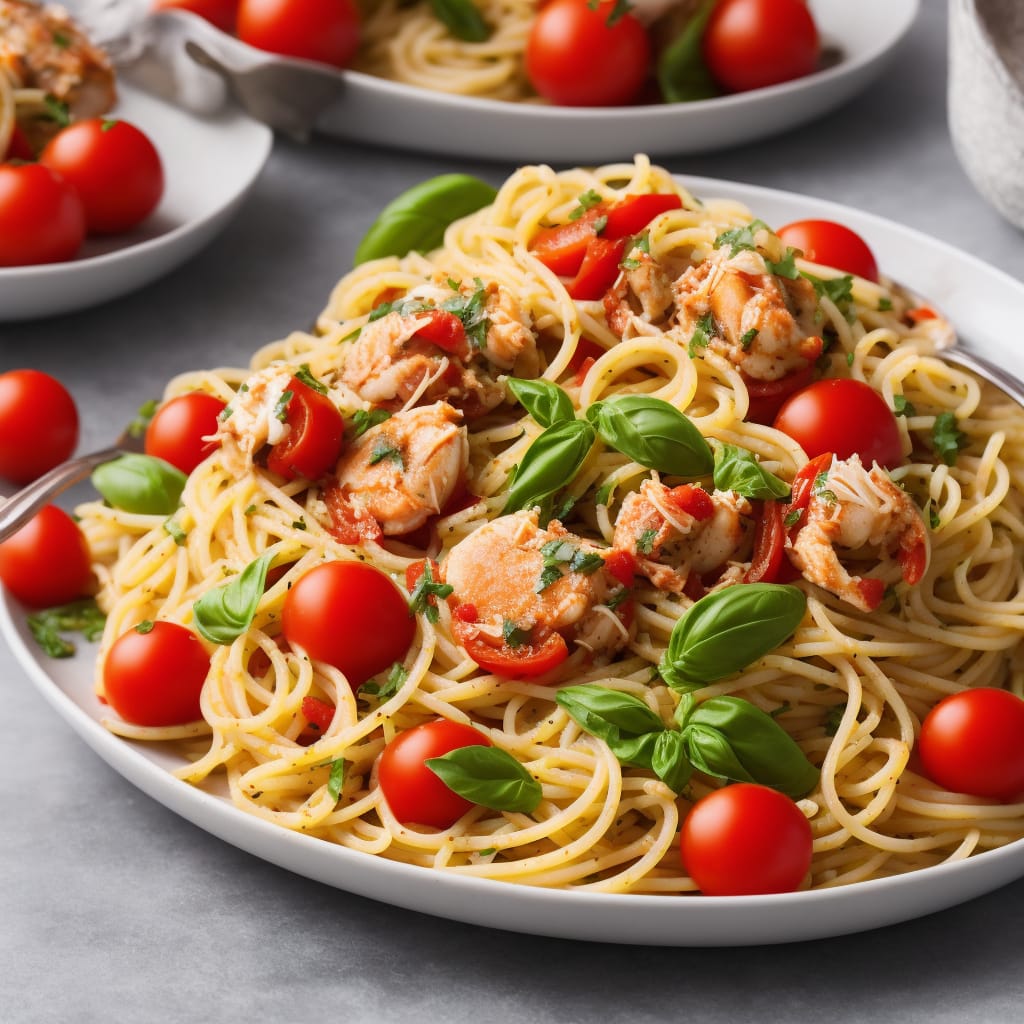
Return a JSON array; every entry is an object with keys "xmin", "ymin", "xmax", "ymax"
[{"xmin": 0, "ymin": 164, "xmax": 85, "ymax": 266}]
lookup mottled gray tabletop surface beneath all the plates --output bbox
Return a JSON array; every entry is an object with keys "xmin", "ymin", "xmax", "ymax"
[{"xmin": 0, "ymin": 0, "xmax": 1024, "ymax": 1024}]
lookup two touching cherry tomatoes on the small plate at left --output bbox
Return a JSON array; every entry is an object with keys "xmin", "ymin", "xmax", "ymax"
[{"xmin": 0, "ymin": 118, "xmax": 164, "ymax": 266}]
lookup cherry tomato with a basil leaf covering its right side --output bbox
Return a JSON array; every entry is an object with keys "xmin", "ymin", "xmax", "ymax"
[{"xmin": 377, "ymin": 718, "xmax": 492, "ymax": 828}]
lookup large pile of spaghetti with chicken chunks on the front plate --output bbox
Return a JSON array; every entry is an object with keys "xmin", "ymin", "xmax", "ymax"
[{"xmin": 78, "ymin": 158, "xmax": 1024, "ymax": 894}]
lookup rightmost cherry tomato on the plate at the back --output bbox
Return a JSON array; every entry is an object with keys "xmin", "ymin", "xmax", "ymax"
[{"xmin": 702, "ymin": 0, "xmax": 820, "ymax": 92}]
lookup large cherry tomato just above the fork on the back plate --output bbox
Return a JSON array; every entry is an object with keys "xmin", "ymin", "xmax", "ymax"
[{"xmin": 238, "ymin": 0, "xmax": 359, "ymax": 68}]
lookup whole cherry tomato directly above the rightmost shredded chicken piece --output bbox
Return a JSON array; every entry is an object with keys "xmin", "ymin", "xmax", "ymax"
[{"xmin": 773, "ymin": 378, "xmax": 903, "ymax": 468}]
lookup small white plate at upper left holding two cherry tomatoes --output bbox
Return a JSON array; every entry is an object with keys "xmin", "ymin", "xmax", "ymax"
[{"xmin": 0, "ymin": 80, "xmax": 273, "ymax": 322}]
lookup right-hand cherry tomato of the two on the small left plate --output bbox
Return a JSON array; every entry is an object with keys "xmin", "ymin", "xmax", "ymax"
[{"xmin": 39, "ymin": 118, "xmax": 164, "ymax": 234}]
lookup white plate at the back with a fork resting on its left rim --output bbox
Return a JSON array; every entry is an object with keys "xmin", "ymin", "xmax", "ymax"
[{"xmin": 149, "ymin": 0, "xmax": 919, "ymax": 164}]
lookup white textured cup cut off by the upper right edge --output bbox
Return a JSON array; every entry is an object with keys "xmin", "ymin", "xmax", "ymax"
[{"xmin": 948, "ymin": 0, "xmax": 1024, "ymax": 227}]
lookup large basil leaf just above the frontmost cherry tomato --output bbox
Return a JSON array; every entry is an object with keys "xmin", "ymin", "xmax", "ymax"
[{"xmin": 682, "ymin": 696, "xmax": 820, "ymax": 800}]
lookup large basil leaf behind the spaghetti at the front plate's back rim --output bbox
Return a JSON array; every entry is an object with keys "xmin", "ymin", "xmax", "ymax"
[{"xmin": 353, "ymin": 174, "xmax": 498, "ymax": 266}]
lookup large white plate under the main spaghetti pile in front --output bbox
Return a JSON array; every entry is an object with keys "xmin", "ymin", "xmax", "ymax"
[{"xmin": 0, "ymin": 178, "xmax": 1024, "ymax": 946}]
